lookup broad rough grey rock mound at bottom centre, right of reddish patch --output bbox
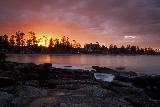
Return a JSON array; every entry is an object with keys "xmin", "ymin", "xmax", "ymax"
[{"xmin": 44, "ymin": 85, "xmax": 130, "ymax": 107}]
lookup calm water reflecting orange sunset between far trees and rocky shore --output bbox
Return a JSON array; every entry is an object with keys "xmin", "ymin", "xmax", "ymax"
[{"xmin": 7, "ymin": 54, "xmax": 160, "ymax": 74}]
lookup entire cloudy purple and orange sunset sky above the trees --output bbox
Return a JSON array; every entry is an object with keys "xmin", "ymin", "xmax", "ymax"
[{"xmin": 0, "ymin": 0, "xmax": 160, "ymax": 48}]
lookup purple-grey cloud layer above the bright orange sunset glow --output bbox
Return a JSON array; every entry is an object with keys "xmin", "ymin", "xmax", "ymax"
[{"xmin": 0, "ymin": 0, "xmax": 160, "ymax": 46}]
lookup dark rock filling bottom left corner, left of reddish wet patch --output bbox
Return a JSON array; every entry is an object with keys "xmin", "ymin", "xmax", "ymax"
[{"xmin": 0, "ymin": 86, "xmax": 48, "ymax": 107}]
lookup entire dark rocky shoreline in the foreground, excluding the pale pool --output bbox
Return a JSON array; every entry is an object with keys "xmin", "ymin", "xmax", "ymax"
[{"xmin": 0, "ymin": 61, "xmax": 160, "ymax": 107}]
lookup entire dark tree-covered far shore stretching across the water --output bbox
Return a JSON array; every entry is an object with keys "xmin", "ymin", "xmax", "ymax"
[{"xmin": 0, "ymin": 31, "xmax": 160, "ymax": 55}]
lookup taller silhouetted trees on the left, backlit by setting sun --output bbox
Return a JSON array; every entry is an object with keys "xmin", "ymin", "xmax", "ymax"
[{"xmin": 0, "ymin": 31, "xmax": 81, "ymax": 53}]
